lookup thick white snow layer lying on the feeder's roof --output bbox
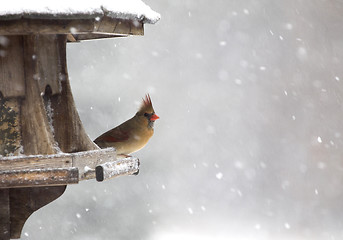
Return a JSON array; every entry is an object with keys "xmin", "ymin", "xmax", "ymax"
[{"xmin": 0, "ymin": 0, "xmax": 161, "ymax": 24}]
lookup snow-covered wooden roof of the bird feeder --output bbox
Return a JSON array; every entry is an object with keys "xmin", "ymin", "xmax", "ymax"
[{"xmin": 0, "ymin": 0, "xmax": 160, "ymax": 41}]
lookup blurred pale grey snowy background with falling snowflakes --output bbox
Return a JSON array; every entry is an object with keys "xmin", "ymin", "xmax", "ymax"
[{"xmin": 22, "ymin": 0, "xmax": 343, "ymax": 240}]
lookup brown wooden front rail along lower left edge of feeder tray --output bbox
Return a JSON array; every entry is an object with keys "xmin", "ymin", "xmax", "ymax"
[{"xmin": 0, "ymin": 168, "xmax": 79, "ymax": 188}]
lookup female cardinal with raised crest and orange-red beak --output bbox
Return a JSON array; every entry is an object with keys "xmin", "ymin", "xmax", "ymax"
[{"xmin": 94, "ymin": 94, "xmax": 159, "ymax": 155}]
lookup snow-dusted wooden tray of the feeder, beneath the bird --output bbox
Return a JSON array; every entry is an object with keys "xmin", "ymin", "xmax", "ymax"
[{"xmin": 0, "ymin": 148, "xmax": 139, "ymax": 188}]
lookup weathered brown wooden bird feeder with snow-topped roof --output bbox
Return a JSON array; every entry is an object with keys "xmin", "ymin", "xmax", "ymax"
[{"xmin": 0, "ymin": 0, "xmax": 159, "ymax": 240}]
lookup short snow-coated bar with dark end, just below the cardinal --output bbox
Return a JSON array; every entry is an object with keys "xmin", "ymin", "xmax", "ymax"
[{"xmin": 95, "ymin": 157, "xmax": 139, "ymax": 182}]
